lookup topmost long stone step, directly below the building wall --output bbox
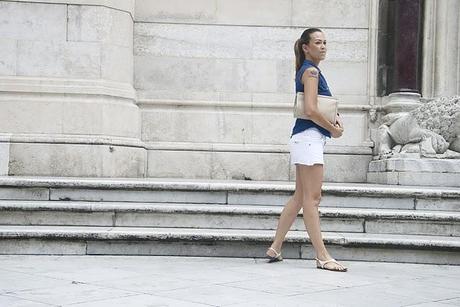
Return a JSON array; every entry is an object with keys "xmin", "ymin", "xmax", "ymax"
[{"xmin": 0, "ymin": 177, "xmax": 460, "ymax": 212}]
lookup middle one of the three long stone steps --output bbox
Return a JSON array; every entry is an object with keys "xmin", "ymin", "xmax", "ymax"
[{"xmin": 0, "ymin": 201, "xmax": 460, "ymax": 236}]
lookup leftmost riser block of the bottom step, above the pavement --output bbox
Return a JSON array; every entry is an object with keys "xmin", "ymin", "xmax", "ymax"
[{"xmin": 0, "ymin": 239, "xmax": 86, "ymax": 255}]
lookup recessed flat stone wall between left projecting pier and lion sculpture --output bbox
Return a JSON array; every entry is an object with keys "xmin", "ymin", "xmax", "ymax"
[{"xmin": 134, "ymin": 0, "xmax": 375, "ymax": 182}]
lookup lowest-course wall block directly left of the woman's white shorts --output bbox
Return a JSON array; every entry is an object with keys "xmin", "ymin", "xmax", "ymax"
[{"xmin": 211, "ymin": 152, "xmax": 289, "ymax": 180}]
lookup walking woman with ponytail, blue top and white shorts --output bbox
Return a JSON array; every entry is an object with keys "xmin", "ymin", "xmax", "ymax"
[{"xmin": 267, "ymin": 28, "xmax": 347, "ymax": 272}]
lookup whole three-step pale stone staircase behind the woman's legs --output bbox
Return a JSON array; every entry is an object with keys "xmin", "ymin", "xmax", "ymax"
[{"xmin": 0, "ymin": 177, "xmax": 460, "ymax": 264}]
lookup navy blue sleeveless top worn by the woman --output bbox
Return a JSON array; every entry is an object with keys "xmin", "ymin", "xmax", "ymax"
[{"xmin": 291, "ymin": 60, "xmax": 332, "ymax": 138}]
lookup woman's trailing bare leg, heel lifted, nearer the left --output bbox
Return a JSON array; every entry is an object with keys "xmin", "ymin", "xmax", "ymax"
[{"xmin": 267, "ymin": 175, "xmax": 303, "ymax": 257}]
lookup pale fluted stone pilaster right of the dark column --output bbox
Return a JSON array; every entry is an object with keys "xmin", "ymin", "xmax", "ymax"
[{"xmin": 422, "ymin": 0, "xmax": 460, "ymax": 98}]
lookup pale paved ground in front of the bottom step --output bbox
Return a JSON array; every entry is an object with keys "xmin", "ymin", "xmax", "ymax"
[{"xmin": 0, "ymin": 256, "xmax": 460, "ymax": 307}]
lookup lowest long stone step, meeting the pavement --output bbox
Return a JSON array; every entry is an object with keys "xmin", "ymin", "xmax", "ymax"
[{"xmin": 0, "ymin": 226, "xmax": 460, "ymax": 265}]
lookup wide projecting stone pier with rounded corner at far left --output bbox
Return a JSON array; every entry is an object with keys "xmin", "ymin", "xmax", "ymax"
[{"xmin": 0, "ymin": 0, "xmax": 145, "ymax": 177}]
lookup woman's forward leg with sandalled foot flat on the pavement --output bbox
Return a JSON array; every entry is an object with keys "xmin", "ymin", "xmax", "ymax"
[{"xmin": 296, "ymin": 164, "xmax": 344, "ymax": 270}]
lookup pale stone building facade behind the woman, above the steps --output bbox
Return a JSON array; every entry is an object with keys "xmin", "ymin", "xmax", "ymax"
[{"xmin": 0, "ymin": 0, "xmax": 460, "ymax": 182}]
